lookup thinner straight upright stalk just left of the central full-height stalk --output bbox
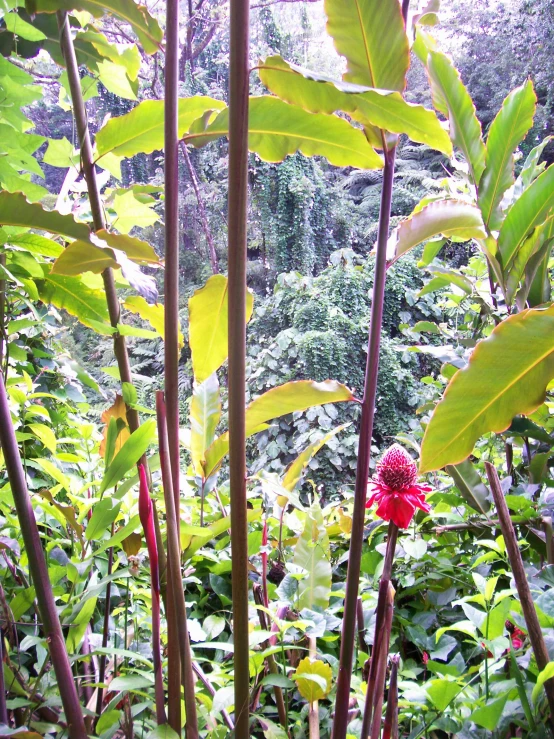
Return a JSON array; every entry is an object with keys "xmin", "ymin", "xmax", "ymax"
[{"xmin": 164, "ymin": 0, "xmax": 179, "ymax": 511}]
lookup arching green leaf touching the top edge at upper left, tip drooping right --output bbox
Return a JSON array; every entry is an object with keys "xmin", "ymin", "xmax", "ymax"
[{"xmin": 26, "ymin": 0, "xmax": 163, "ymax": 54}]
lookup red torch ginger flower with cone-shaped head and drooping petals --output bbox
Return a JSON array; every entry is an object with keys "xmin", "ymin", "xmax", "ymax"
[{"xmin": 366, "ymin": 444, "xmax": 433, "ymax": 529}]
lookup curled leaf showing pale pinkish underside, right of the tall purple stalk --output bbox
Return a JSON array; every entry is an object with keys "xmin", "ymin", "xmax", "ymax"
[{"xmin": 387, "ymin": 200, "xmax": 487, "ymax": 262}]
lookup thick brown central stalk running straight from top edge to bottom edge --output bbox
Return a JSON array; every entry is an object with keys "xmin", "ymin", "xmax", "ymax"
[{"xmin": 228, "ymin": 0, "xmax": 250, "ymax": 739}]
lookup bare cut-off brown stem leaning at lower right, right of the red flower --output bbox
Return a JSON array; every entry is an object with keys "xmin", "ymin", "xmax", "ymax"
[{"xmin": 485, "ymin": 462, "xmax": 554, "ymax": 731}]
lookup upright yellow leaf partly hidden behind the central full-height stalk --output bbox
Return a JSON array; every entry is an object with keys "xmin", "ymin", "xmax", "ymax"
[{"xmin": 189, "ymin": 275, "xmax": 254, "ymax": 382}]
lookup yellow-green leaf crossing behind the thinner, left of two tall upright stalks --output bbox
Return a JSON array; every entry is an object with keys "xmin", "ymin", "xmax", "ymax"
[{"xmin": 96, "ymin": 96, "xmax": 225, "ymax": 159}]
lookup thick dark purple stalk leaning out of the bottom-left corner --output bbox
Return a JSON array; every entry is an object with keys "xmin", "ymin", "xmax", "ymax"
[{"xmin": 0, "ymin": 373, "xmax": 87, "ymax": 739}]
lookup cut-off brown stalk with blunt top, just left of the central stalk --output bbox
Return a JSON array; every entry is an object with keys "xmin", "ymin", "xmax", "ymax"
[{"xmin": 156, "ymin": 398, "xmax": 198, "ymax": 739}]
